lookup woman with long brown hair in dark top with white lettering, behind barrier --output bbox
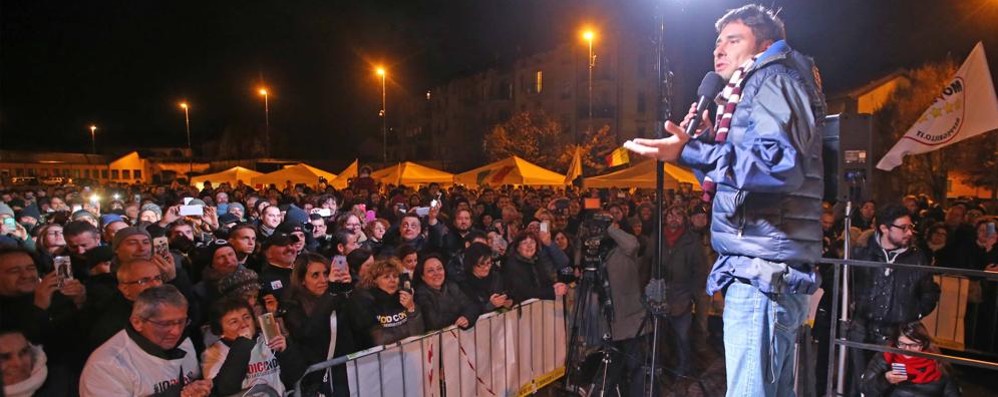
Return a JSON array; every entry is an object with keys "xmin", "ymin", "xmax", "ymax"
[{"xmin": 282, "ymin": 254, "xmax": 359, "ymax": 396}]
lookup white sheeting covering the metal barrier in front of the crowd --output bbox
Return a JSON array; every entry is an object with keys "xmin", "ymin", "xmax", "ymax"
[{"xmin": 346, "ymin": 299, "xmax": 566, "ymax": 397}]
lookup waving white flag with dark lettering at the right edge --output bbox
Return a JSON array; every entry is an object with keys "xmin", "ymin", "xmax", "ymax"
[{"xmin": 877, "ymin": 42, "xmax": 998, "ymax": 171}]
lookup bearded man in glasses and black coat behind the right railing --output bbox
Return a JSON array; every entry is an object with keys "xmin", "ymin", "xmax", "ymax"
[{"xmin": 848, "ymin": 204, "xmax": 939, "ymax": 392}]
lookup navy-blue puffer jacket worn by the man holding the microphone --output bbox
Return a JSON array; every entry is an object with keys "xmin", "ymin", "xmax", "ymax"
[{"xmin": 680, "ymin": 41, "xmax": 825, "ymax": 294}]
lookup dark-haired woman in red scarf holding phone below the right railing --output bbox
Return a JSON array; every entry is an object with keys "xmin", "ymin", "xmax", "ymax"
[{"xmin": 860, "ymin": 321, "xmax": 960, "ymax": 397}]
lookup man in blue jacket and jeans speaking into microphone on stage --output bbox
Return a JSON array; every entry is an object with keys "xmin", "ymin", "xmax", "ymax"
[{"xmin": 625, "ymin": 5, "xmax": 825, "ymax": 396}]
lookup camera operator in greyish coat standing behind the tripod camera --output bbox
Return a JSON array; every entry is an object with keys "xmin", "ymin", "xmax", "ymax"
[{"xmin": 576, "ymin": 212, "xmax": 648, "ymax": 396}]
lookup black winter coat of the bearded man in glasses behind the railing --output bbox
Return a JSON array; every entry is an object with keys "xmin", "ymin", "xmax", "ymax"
[{"xmin": 853, "ymin": 233, "xmax": 939, "ymax": 324}]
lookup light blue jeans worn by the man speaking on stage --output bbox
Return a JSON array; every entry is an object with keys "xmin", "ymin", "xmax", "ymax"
[{"xmin": 724, "ymin": 282, "xmax": 809, "ymax": 397}]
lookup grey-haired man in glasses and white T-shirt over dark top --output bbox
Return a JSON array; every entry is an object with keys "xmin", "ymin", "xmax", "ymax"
[{"xmin": 80, "ymin": 285, "xmax": 212, "ymax": 397}]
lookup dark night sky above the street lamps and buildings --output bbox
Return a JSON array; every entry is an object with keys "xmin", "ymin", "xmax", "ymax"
[{"xmin": 0, "ymin": 0, "xmax": 998, "ymax": 158}]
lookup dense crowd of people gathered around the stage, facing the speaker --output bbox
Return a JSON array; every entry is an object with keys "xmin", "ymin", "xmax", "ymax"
[{"xmin": 0, "ymin": 172, "xmax": 998, "ymax": 396}]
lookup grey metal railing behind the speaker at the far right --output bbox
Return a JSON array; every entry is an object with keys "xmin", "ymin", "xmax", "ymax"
[{"xmin": 822, "ymin": 258, "xmax": 998, "ymax": 396}]
